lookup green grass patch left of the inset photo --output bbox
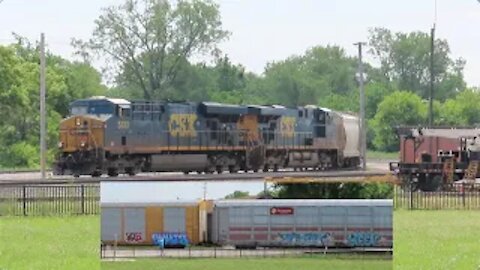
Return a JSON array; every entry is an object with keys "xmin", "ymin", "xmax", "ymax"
[{"xmin": 0, "ymin": 216, "xmax": 100, "ymax": 270}]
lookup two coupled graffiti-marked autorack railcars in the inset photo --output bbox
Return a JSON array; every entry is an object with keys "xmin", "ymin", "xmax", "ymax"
[{"xmin": 101, "ymin": 200, "xmax": 393, "ymax": 248}]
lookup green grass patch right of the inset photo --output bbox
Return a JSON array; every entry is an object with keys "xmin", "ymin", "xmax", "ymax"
[{"xmin": 393, "ymin": 210, "xmax": 480, "ymax": 270}]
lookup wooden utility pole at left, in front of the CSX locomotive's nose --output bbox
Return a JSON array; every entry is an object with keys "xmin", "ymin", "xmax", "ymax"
[{"xmin": 40, "ymin": 33, "xmax": 47, "ymax": 180}]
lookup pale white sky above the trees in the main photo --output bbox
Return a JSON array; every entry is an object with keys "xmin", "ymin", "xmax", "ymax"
[{"xmin": 0, "ymin": 0, "xmax": 480, "ymax": 86}]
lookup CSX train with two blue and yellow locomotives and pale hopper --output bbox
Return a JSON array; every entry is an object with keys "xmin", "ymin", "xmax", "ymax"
[{"xmin": 53, "ymin": 97, "xmax": 359, "ymax": 176}]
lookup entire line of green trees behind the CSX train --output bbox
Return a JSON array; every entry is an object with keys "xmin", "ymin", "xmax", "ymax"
[{"xmin": 0, "ymin": 0, "xmax": 480, "ymax": 167}]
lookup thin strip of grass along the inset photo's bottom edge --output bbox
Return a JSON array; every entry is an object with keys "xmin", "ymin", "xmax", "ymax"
[{"xmin": 102, "ymin": 256, "xmax": 392, "ymax": 270}]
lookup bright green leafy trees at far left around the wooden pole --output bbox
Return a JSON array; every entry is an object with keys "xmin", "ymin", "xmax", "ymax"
[{"xmin": 0, "ymin": 39, "xmax": 105, "ymax": 167}]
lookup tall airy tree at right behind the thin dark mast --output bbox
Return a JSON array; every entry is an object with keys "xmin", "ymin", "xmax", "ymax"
[{"xmin": 369, "ymin": 28, "xmax": 466, "ymax": 100}]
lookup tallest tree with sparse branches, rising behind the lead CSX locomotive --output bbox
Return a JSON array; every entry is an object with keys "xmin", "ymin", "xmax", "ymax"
[{"xmin": 73, "ymin": 0, "xmax": 228, "ymax": 99}]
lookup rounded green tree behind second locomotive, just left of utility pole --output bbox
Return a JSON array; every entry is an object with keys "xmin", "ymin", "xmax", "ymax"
[{"xmin": 262, "ymin": 46, "xmax": 358, "ymax": 106}]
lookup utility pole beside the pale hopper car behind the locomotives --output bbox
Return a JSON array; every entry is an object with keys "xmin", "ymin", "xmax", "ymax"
[{"xmin": 353, "ymin": 42, "xmax": 367, "ymax": 170}]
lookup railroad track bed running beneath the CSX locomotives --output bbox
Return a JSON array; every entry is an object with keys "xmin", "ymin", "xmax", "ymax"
[{"xmin": 0, "ymin": 170, "xmax": 393, "ymax": 185}]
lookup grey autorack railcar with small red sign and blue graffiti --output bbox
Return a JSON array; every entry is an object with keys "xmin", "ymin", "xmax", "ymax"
[{"xmin": 211, "ymin": 200, "xmax": 393, "ymax": 248}]
